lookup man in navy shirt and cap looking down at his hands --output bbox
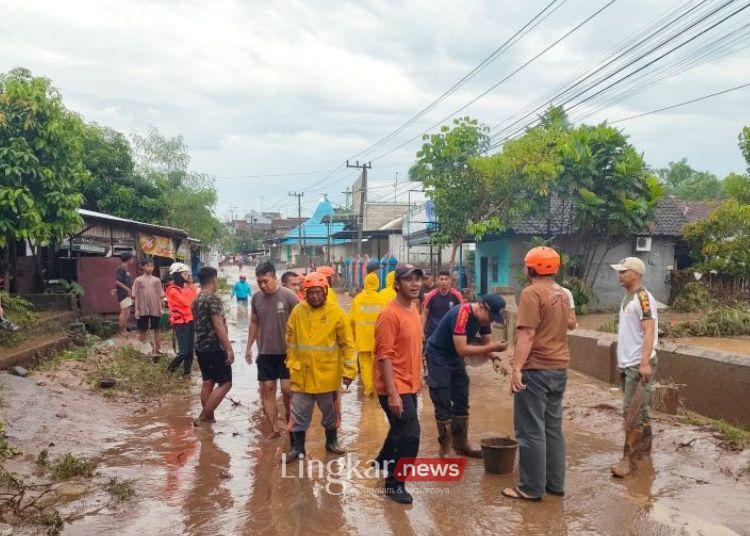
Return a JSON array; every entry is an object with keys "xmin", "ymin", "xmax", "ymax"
[{"xmin": 425, "ymin": 294, "xmax": 508, "ymax": 458}]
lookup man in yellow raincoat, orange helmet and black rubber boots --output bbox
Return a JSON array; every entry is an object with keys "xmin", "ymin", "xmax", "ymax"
[{"xmin": 284, "ymin": 272, "xmax": 357, "ymax": 463}]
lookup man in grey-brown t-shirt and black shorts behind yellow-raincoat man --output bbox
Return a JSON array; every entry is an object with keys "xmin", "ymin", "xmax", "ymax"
[{"xmin": 245, "ymin": 262, "xmax": 299, "ymax": 437}]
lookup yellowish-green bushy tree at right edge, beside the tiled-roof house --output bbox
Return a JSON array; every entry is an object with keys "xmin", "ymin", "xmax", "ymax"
[{"xmin": 683, "ymin": 199, "xmax": 750, "ymax": 279}]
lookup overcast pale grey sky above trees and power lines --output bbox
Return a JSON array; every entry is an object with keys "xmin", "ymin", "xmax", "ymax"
[{"xmin": 0, "ymin": 0, "xmax": 750, "ymax": 217}]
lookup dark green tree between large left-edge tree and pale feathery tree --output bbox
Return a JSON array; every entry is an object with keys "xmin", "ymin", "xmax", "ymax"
[{"xmin": 83, "ymin": 123, "xmax": 167, "ymax": 224}]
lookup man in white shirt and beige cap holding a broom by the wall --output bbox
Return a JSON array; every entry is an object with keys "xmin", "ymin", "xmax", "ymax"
[{"xmin": 611, "ymin": 257, "xmax": 659, "ymax": 477}]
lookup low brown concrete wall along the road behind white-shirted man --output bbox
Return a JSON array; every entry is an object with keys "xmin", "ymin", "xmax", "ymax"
[{"xmin": 568, "ymin": 330, "xmax": 750, "ymax": 426}]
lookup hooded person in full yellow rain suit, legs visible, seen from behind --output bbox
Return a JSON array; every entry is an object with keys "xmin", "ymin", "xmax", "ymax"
[{"xmin": 349, "ymin": 273, "xmax": 383, "ymax": 396}]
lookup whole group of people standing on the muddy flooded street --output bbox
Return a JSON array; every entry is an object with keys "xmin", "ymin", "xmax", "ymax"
[{"xmin": 111, "ymin": 247, "xmax": 656, "ymax": 503}]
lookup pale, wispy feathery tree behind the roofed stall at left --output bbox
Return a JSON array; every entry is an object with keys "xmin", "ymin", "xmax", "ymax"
[{"xmin": 132, "ymin": 128, "xmax": 224, "ymax": 244}]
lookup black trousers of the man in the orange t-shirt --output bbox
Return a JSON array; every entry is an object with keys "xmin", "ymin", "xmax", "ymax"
[{"xmin": 377, "ymin": 394, "xmax": 421, "ymax": 485}]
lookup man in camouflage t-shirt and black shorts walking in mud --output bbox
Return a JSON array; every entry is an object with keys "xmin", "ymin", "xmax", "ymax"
[{"xmin": 193, "ymin": 266, "xmax": 234, "ymax": 426}]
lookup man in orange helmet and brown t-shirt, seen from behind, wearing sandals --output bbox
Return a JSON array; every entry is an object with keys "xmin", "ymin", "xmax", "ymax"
[{"xmin": 503, "ymin": 247, "xmax": 570, "ymax": 501}]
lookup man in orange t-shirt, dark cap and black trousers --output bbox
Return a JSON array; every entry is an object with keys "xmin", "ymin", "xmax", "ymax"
[{"xmin": 375, "ymin": 264, "xmax": 423, "ymax": 504}]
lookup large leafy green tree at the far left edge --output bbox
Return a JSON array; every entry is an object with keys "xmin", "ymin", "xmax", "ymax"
[{"xmin": 0, "ymin": 69, "xmax": 88, "ymax": 292}]
